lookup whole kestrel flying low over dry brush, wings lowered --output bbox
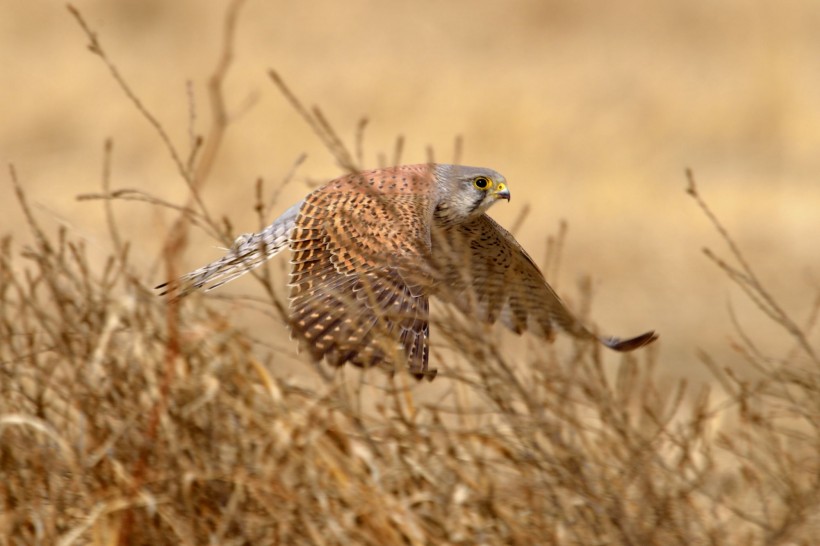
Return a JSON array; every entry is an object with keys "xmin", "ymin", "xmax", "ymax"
[{"xmin": 157, "ymin": 164, "xmax": 657, "ymax": 379}]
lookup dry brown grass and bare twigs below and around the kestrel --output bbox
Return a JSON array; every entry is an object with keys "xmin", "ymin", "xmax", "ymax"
[{"xmin": 0, "ymin": 2, "xmax": 820, "ymax": 545}]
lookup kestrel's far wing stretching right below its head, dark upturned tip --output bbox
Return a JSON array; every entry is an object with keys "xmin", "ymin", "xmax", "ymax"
[{"xmin": 433, "ymin": 214, "xmax": 657, "ymax": 351}]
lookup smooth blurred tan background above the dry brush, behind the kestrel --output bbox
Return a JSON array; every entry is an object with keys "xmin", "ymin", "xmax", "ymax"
[{"xmin": 0, "ymin": 0, "xmax": 820, "ymax": 375}]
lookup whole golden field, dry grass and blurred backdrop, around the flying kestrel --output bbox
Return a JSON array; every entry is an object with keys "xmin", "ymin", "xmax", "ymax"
[{"xmin": 0, "ymin": 0, "xmax": 820, "ymax": 544}]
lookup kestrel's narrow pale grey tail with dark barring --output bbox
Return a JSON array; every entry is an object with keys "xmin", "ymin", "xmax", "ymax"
[{"xmin": 155, "ymin": 202, "xmax": 302, "ymax": 299}]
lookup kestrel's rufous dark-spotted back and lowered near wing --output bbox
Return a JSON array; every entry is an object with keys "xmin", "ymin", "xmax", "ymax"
[{"xmin": 290, "ymin": 168, "xmax": 442, "ymax": 379}]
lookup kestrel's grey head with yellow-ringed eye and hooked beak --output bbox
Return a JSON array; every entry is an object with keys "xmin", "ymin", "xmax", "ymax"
[{"xmin": 435, "ymin": 165, "xmax": 510, "ymax": 224}]
